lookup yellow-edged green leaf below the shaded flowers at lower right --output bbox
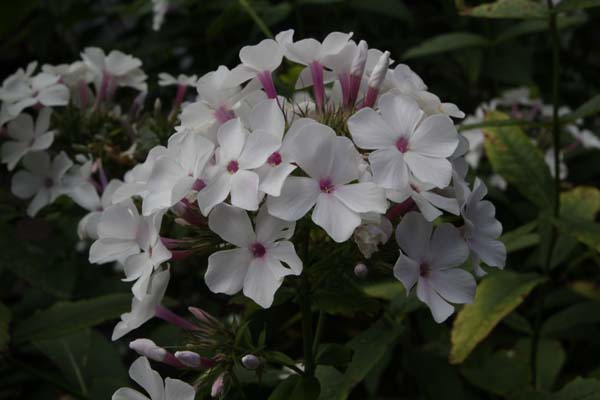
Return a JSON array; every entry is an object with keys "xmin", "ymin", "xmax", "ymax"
[{"xmin": 449, "ymin": 271, "xmax": 544, "ymax": 364}]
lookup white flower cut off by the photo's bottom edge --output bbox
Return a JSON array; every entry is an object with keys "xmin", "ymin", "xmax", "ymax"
[{"xmin": 111, "ymin": 357, "xmax": 196, "ymax": 400}]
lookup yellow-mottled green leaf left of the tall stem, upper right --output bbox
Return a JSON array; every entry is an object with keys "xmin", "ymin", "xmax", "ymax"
[{"xmin": 483, "ymin": 112, "xmax": 554, "ymax": 208}]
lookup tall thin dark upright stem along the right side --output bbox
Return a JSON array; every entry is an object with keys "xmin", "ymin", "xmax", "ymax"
[{"xmin": 531, "ymin": 0, "xmax": 561, "ymax": 389}]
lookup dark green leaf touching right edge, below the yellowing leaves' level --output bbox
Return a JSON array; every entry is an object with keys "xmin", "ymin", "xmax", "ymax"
[{"xmin": 541, "ymin": 301, "xmax": 600, "ymax": 336}]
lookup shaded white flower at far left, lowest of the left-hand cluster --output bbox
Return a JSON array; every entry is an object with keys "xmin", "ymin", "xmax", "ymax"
[{"xmin": 11, "ymin": 151, "xmax": 73, "ymax": 217}]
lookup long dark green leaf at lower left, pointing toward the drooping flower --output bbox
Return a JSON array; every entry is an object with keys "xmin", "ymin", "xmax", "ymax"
[{"xmin": 13, "ymin": 294, "xmax": 131, "ymax": 343}]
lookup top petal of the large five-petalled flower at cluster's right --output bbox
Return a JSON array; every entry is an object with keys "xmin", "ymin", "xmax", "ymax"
[{"xmin": 378, "ymin": 93, "xmax": 424, "ymax": 139}]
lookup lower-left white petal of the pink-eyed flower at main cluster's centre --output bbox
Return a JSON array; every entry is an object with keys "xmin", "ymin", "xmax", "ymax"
[{"xmin": 267, "ymin": 176, "xmax": 320, "ymax": 221}]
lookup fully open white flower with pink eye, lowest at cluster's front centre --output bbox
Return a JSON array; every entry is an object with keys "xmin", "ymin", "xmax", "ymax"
[{"xmin": 205, "ymin": 204, "xmax": 302, "ymax": 308}]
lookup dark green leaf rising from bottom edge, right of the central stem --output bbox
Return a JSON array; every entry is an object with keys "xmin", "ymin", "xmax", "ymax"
[{"xmin": 317, "ymin": 320, "xmax": 402, "ymax": 400}]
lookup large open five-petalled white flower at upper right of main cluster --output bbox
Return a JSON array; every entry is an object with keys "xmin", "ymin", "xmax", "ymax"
[{"xmin": 348, "ymin": 94, "xmax": 458, "ymax": 190}]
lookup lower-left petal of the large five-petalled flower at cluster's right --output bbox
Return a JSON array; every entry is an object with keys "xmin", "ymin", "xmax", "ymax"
[{"xmin": 369, "ymin": 148, "xmax": 409, "ymax": 190}]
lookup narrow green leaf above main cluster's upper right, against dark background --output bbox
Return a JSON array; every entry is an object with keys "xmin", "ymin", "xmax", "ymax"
[{"xmin": 402, "ymin": 32, "xmax": 490, "ymax": 59}]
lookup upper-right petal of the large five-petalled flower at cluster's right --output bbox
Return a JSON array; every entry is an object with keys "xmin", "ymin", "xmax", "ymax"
[{"xmin": 410, "ymin": 114, "xmax": 458, "ymax": 158}]
